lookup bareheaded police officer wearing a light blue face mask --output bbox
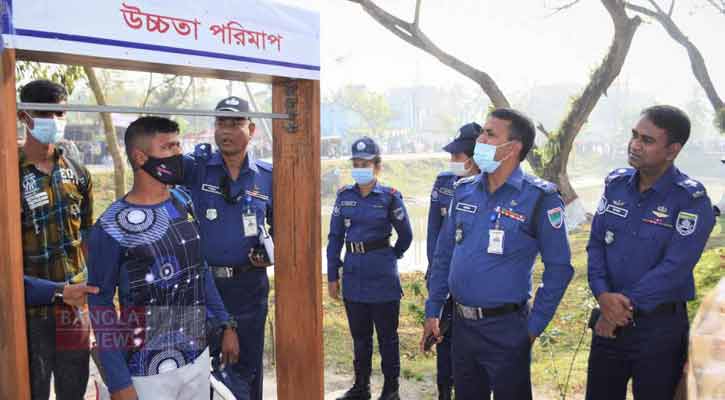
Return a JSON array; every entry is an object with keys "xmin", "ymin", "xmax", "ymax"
[{"xmin": 421, "ymin": 108, "xmax": 574, "ymax": 400}]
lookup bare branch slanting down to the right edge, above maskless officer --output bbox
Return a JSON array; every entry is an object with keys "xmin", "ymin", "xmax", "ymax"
[{"xmin": 625, "ymin": 0, "xmax": 725, "ymax": 113}]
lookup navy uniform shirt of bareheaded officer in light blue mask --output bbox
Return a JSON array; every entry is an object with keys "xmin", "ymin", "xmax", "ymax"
[{"xmin": 426, "ymin": 168, "xmax": 574, "ymax": 336}]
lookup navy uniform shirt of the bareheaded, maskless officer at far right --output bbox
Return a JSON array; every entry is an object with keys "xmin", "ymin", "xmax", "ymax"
[{"xmin": 587, "ymin": 166, "xmax": 715, "ymax": 311}]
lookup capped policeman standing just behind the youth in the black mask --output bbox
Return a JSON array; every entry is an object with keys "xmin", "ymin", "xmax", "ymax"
[{"xmin": 184, "ymin": 97, "xmax": 272, "ymax": 400}]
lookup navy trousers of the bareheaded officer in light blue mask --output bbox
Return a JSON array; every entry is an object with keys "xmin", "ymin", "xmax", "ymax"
[{"xmin": 452, "ymin": 310, "xmax": 532, "ymax": 400}]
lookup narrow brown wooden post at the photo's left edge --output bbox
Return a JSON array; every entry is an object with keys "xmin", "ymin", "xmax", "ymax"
[{"xmin": 0, "ymin": 49, "xmax": 30, "ymax": 400}]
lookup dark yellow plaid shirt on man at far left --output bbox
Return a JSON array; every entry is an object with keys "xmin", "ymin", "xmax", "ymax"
[{"xmin": 20, "ymin": 149, "xmax": 93, "ymax": 316}]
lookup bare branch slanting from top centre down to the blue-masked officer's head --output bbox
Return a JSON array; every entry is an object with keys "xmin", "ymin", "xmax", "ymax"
[{"xmin": 348, "ymin": 0, "xmax": 510, "ymax": 107}]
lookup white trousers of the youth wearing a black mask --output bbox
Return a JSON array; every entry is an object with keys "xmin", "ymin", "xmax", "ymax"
[{"xmin": 131, "ymin": 348, "xmax": 211, "ymax": 400}]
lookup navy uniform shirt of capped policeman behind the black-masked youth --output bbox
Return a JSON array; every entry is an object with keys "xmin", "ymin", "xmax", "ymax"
[{"xmin": 184, "ymin": 143, "xmax": 273, "ymax": 304}]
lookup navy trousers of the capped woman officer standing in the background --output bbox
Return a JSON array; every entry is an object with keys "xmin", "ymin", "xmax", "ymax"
[{"xmin": 345, "ymin": 300, "xmax": 400, "ymax": 378}]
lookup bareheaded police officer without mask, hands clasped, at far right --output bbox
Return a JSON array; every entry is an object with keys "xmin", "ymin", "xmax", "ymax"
[{"xmin": 587, "ymin": 106, "xmax": 714, "ymax": 400}]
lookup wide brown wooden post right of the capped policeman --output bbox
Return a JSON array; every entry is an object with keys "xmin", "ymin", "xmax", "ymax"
[{"xmin": 272, "ymin": 80, "xmax": 324, "ymax": 400}]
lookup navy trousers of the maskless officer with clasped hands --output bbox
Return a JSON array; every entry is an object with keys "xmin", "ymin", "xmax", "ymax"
[{"xmin": 586, "ymin": 307, "xmax": 689, "ymax": 400}]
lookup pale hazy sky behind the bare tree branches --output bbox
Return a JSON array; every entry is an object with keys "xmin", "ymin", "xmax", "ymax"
[{"xmin": 278, "ymin": 0, "xmax": 725, "ymax": 109}]
